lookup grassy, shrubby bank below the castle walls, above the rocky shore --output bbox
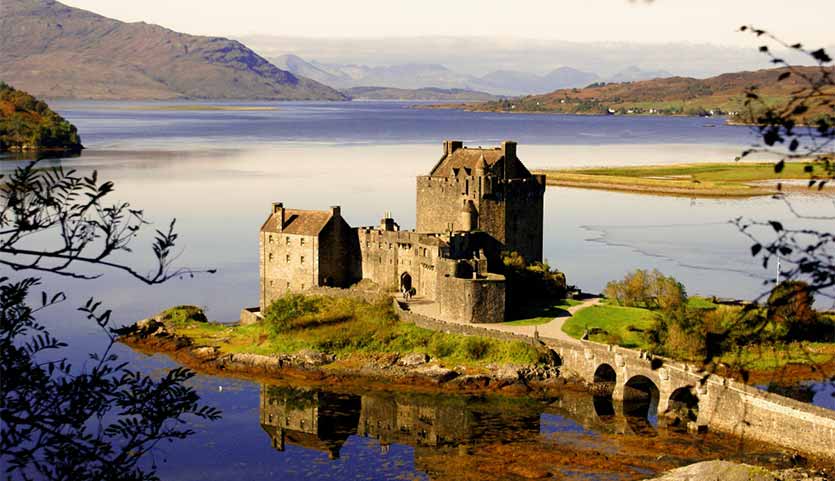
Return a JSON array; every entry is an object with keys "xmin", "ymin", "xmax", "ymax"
[{"xmin": 162, "ymin": 295, "xmax": 544, "ymax": 368}]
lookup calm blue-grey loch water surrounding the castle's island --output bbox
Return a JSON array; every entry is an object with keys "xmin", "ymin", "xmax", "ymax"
[{"xmin": 0, "ymin": 102, "xmax": 835, "ymax": 479}]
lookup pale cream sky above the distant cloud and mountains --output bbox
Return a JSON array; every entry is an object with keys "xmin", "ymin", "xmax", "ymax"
[{"xmin": 63, "ymin": 0, "xmax": 835, "ymax": 47}]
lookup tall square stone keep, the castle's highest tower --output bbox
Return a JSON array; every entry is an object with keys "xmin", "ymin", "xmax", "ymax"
[{"xmin": 417, "ymin": 140, "xmax": 545, "ymax": 261}]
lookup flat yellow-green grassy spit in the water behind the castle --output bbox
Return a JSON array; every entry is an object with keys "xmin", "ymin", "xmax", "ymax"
[{"xmin": 537, "ymin": 162, "xmax": 832, "ymax": 197}]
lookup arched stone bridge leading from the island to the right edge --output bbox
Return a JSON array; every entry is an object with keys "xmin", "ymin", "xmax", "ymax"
[{"xmin": 542, "ymin": 338, "xmax": 835, "ymax": 458}]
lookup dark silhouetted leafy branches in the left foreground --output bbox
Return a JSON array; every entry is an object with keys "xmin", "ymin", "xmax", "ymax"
[{"xmin": 0, "ymin": 162, "xmax": 220, "ymax": 480}]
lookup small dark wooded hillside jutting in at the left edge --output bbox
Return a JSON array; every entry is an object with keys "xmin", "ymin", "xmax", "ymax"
[{"xmin": 0, "ymin": 82, "xmax": 83, "ymax": 152}]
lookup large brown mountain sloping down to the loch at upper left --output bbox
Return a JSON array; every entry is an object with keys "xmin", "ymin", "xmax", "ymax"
[{"xmin": 0, "ymin": 0, "xmax": 345, "ymax": 100}]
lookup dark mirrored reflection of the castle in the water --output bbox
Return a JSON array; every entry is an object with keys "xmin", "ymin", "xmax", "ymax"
[{"xmin": 260, "ymin": 385, "xmax": 541, "ymax": 464}]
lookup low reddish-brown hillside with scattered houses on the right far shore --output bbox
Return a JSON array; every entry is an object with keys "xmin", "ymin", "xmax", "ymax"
[{"xmin": 454, "ymin": 67, "xmax": 832, "ymax": 121}]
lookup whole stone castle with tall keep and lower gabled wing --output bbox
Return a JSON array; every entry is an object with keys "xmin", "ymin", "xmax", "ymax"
[{"xmin": 259, "ymin": 140, "xmax": 545, "ymax": 322}]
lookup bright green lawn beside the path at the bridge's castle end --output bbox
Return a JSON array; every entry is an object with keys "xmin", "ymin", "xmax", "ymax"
[{"xmin": 562, "ymin": 305, "xmax": 655, "ymax": 349}]
